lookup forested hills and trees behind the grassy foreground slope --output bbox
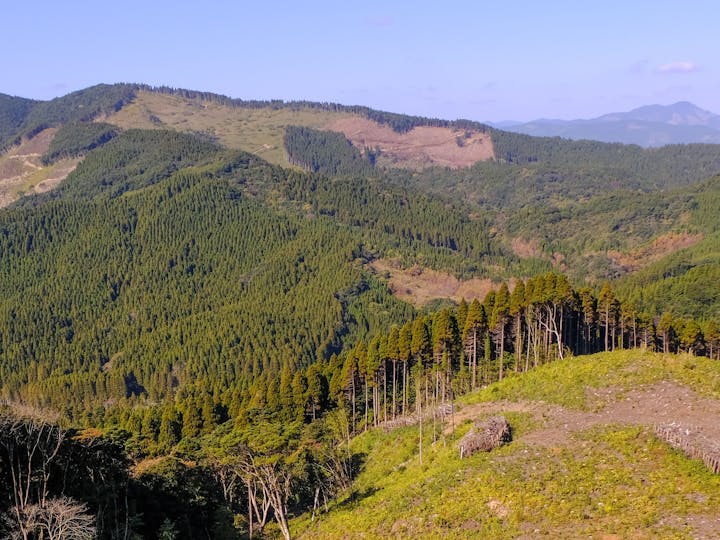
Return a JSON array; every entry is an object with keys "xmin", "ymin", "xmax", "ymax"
[{"xmin": 0, "ymin": 85, "xmax": 720, "ymax": 538}]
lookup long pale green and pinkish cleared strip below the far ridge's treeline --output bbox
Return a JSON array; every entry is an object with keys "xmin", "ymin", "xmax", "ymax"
[{"xmin": 103, "ymin": 91, "xmax": 493, "ymax": 168}]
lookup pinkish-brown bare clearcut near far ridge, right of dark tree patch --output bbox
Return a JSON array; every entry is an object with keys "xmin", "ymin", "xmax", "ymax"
[{"xmin": 325, "ymin": 116, "xmax": 495, "ymax": 169}]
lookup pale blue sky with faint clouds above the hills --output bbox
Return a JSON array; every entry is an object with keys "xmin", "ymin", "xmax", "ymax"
[{"xmin": 0, "ymin": 0, "xmax": 720, "ymax": 121}]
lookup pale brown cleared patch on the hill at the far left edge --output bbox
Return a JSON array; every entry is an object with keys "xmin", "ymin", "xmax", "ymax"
[{"xmin": 0, "ymin": 128, "xmax": 80, "ymax": 208}]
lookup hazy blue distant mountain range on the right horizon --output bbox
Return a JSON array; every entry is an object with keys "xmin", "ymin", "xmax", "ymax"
[{"xmin": 493, "ymin": 101, "xmax": 720, "ymax": 147}]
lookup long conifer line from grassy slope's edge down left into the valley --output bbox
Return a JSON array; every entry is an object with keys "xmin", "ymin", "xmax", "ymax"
[{"xmin": 106, "ymin": 273, "xmax": 720, "ymax": 452}]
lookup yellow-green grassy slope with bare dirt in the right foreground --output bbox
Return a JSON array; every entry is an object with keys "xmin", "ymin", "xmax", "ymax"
[{"xmin": 291, "ymin": 351, "xmax": 720, "ymax": 538}]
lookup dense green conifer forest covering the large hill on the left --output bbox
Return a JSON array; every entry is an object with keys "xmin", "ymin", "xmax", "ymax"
[{"xmin": 0, "ymin": 127, "xmax": 422, "ymax": 422}]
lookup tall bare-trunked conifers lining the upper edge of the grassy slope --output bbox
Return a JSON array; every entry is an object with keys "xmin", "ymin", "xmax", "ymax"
[{"xmin": 304, "ymin": 273, "xmax": 720, "ymax": 434}]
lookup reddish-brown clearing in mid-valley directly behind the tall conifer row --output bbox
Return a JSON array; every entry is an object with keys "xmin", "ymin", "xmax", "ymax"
[{"xmin": 369, "ymin": 259, "xmax": 496, "ymax": 307}]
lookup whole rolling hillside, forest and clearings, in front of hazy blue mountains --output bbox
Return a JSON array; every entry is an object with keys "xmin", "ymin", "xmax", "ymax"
[{"xmin": 0, "ymin": 85, "xmax": 720, "ymax": 540}]
